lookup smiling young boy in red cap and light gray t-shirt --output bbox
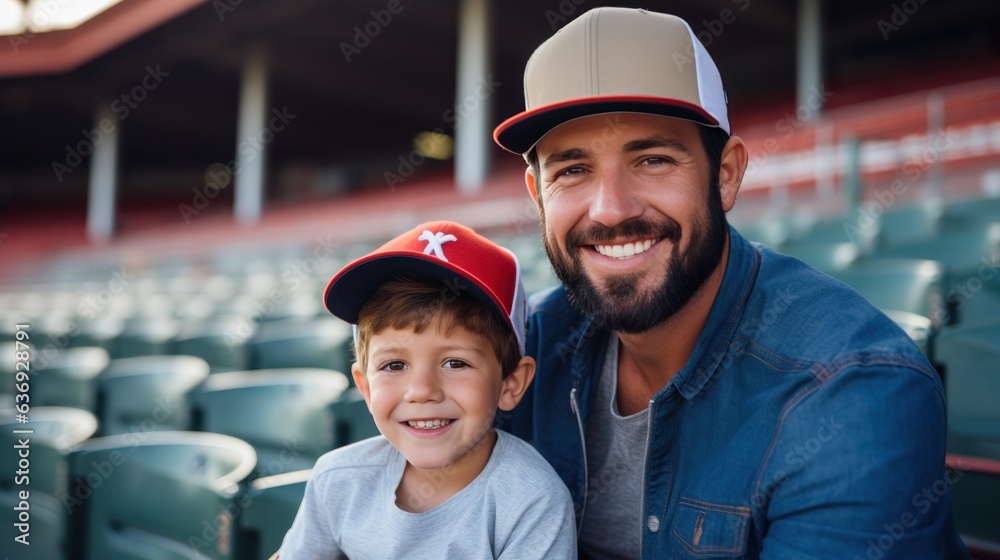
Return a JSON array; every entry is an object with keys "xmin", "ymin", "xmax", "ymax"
[{"xmin": 281, "ymin": 222, "xmax": 576, "ymax": 560}]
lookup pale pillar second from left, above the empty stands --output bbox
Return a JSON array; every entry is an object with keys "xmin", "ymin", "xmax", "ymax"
[{"xmin": 233, "ymin": 48, "xmax": 271, "ymax": 225}]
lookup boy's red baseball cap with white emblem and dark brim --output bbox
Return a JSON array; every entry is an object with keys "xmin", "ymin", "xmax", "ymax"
[{"xmin": 323, "ymin": 221, "xmax": 527, "ymax": 356}]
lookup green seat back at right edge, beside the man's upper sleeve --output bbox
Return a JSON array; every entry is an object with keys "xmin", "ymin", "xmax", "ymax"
[{"xmin": 935, "ymin": 321, "xmax": 1000, "ymax": 444}]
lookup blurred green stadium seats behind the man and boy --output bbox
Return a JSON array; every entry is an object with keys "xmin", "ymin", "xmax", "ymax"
[{"xmin": 0, "ymin": 194, "xmax": 1000, "ymax": 558}]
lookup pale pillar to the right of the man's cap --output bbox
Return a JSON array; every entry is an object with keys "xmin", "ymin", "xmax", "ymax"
[{"xmin": 795, "ymin": 0, "xmax": 824, "ymax": 119}]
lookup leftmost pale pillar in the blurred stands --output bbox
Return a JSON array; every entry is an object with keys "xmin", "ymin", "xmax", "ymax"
[{"xmin": 87, "ymin": 104, "xmax": 121, "ymax": 243}]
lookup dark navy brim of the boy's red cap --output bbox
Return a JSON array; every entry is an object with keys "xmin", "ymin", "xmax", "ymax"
[{"xmin": 323, "ymin": 255, "xmax": 513, "ymax": 328}]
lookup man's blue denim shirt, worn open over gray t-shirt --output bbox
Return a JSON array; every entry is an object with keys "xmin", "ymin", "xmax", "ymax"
[{"xmin": 508, "ymin": 228, "xmax": 968, "ymax": 560}]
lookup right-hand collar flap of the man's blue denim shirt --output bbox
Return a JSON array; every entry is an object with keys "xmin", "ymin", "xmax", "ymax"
[{"xmin": 668, "ymin": 226, "xmax": 760, "ymax": 400}]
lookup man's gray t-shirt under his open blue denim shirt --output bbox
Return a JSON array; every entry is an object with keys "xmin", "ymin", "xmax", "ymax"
[{"xmin": 580, "ymin": 335, "xmax": 649, "ymax": 559}]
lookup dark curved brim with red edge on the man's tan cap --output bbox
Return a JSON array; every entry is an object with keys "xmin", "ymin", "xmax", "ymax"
[{"xmin": 493, "ymin": 95, "xmax": 719, "ymax": 154}]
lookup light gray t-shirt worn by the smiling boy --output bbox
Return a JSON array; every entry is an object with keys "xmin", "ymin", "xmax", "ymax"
[{"xmin": 281, "ymin": 431, "xmax": 576, "ymax": 560}]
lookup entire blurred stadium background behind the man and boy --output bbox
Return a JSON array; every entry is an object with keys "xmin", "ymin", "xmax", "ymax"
[{"xmin": 0, "ymin": 0, "xmax": 1000, "ymax": 559}]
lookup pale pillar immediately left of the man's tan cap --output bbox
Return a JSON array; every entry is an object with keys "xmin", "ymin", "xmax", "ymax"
[{"xmin": 455, "ymin": 0, "xmax": 495, "ymax": 193}]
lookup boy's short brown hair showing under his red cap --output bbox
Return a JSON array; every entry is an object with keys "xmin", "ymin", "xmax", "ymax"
[{"xmin": 354, "ymin": 278, "xmax": 521, "ymax": 379}]
